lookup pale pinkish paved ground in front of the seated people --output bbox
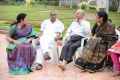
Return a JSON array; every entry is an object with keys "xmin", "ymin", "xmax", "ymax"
[{"xmin": 0, "ymin": 34, "xmax": 120, "ymax": 80}]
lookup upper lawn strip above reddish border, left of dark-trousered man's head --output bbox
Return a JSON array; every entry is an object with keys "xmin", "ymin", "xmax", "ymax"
[{"xmin": 0, "ymin": 5, "xmax": 73, "ymax": 20}]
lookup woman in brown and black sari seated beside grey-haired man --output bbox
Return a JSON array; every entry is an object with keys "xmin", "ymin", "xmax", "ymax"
[{"xmin": 76, "ymin": 11, "xmax": 117, "ymax": 72}]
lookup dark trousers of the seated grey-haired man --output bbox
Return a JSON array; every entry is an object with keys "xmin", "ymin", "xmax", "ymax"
[{"xmin": 60, "ymin": 38, "xmax": 82, "ymax": 63}]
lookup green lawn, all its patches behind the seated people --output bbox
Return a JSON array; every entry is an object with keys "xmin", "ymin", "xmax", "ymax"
[{"xmin": 0, "ymin": 5, "xmax": 120, "ymax": 31}]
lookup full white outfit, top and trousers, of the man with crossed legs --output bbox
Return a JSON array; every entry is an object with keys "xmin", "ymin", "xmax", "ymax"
[{"xmin": 36, "ymin": 19, "xmax": 64, "ymax": 64}]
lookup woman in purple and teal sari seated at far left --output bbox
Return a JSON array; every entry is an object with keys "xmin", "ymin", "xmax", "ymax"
[{"xmin": 6, "ymin": 13, "xmax": 37, "ymax": 75}]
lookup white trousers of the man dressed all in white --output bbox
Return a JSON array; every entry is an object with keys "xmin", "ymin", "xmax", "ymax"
[{"xmin": 36, "ymin": 36, "xmax": 58, "ymax": 64}]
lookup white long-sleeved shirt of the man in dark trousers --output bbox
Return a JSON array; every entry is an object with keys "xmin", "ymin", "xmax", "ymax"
[{"xmin": 66, "ymin": 19, "xmax": 91, "ymax": 38}]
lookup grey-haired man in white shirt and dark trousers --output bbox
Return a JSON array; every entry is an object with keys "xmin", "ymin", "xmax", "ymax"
[{"xmin": 58, "ymin": 10, "xmax": 91, "ymax": 70}]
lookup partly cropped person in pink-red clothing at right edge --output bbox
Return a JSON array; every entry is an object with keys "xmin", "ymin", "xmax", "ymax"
[{"xmin": 108, "ymin": 29, "xmax": 120, "ymax": 76}]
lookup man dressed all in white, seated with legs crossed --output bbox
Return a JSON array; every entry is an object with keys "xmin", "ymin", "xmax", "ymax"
[{"xmin": 36, "ymin": 10, "xmax": 64, "ymax": 70}]
